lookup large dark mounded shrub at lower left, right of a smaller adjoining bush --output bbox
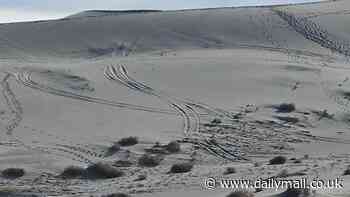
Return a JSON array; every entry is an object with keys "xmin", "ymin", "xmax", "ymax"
[{"xmin": 86, "ymin": 163, "xmax": 124, "ymax": 179}]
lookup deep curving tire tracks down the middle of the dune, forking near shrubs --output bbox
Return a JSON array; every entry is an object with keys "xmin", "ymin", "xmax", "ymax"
[{"xmin": 104, "ymin": 65, "xmax": 240, "ymax": 160}]
